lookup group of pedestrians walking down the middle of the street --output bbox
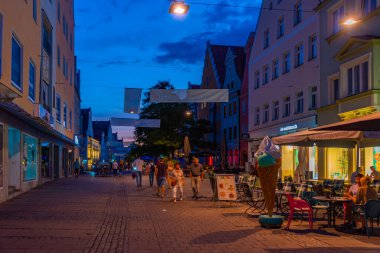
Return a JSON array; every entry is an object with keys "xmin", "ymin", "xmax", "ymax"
[{"xmin": 133, "ymin": 157, "xmax": 204, "ymax": 202}]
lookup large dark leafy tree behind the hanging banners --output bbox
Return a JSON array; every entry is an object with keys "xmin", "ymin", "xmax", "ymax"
[{"xmin": 134, "ymin": 81, "xmax": 212, "ymax": 156}]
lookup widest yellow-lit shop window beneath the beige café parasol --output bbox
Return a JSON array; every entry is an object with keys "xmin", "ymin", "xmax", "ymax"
[{"xmin": 326, "ymin": 148, "xmax": 353, "ymax": 180}]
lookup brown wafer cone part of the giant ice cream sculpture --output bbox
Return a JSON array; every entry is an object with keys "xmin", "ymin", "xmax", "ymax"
[{"xmin": 257, "ymin": 158, "xmax": 281, "ymax": 217}]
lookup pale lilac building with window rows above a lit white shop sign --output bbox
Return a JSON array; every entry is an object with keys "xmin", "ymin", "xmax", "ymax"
[{"xmin": 248, "ymin": 0, "xmax": 320, "ymax": 179}]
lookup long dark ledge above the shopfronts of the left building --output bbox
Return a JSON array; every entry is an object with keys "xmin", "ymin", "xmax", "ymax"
[{"xmin": 0, "ymin": 102, "xmax": 74, "ymax": 145}]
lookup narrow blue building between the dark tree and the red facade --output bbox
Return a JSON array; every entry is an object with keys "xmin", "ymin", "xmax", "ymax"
[{"xmin": 220, "ymin": 47, "xmax": 245, "ymax": 168}]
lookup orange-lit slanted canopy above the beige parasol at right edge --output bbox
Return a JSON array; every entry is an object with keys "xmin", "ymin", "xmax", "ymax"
[{"xmin": 315, "ymin": 112, "xmax": 380, "ymax": 131}]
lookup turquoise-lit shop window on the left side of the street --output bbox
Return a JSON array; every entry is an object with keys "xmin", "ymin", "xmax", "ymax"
[{"xmin": 22, "ymin": 134, "xmax": 38, "ymax": 181}]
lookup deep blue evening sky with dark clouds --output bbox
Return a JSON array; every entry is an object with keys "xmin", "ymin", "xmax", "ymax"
[{"xmin": 75, "ymin": 0, "xmax": 261, "ymax": 138}]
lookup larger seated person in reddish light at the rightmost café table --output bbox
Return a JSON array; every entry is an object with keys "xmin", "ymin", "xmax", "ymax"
[{"xmin": 353, "ymin": 176, "xmax": 377, "ymax": 229}]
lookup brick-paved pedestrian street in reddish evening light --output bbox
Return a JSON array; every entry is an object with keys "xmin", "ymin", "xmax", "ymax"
[{"xmin": 0, "ymin": 176, "xmax": 380, "ymax": 253}]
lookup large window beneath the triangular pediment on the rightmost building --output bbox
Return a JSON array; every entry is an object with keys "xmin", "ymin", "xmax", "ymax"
[{"xmin": 347, "ymin": 61, "xmax": 369, "ymax": 96}]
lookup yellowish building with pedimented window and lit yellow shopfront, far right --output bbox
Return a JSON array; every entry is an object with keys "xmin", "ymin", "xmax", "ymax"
[{"xmin": 317, "ymin": 0, "xmax": 380, "ymax": 179}]
